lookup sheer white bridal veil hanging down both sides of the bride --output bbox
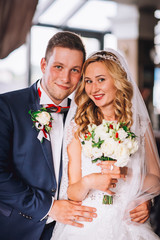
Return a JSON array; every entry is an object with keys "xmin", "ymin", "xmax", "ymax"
[{"xmin": 53, "ymin": 49, "xmax": 160, "ymax": 239}]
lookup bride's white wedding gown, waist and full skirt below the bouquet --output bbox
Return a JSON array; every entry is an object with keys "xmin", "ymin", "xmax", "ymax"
[{"xmin": 52, "ymin": 140, "xmax": 160, "ymax": 240}]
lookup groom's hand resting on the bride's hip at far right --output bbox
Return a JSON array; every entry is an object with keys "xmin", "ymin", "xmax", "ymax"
[{"xmin": 130, "ymin": 200, "xmax": 151, "ymax": 223}]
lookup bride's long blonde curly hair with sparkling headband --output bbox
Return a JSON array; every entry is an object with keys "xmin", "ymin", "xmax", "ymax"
[{"xmin": 75, "ymin": 51, "xmax": 133, "ymax": 136}]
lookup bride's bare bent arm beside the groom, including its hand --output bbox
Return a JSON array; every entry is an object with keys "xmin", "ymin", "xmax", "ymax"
[{"xmin": 67, "ymin": 137, "xmax": 119, "ymax": 201}]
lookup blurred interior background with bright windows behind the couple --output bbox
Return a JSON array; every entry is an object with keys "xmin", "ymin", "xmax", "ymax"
[{"xmin": 0, "ymin": 0, "xmax": 160, "ymax": 236}]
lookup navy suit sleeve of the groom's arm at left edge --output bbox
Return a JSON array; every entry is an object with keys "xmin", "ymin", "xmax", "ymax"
[{"xmin": 0, "ymin": 95, "xmax": 52, "ymax": 221}]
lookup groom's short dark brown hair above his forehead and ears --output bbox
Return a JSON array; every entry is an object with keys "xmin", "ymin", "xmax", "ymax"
[{"xmin": 45, "ymin": 31, "xmax": 86, "ymax": 62}]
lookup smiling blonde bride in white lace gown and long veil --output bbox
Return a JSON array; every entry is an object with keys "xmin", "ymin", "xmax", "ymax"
[{"xmin": 51, "ymin": 49, "xmax": 160, "ymax": 240}]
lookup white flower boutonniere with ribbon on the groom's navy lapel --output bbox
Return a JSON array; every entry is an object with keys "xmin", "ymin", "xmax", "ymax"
[{"xmin": 28, "ymin": 108, "xmax": 53, "ymax": 143}]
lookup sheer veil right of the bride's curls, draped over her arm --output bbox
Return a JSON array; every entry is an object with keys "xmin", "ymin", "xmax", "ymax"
[{"xmin": 106, "ymin": 49, "xmax": 160, "ymax": 213}]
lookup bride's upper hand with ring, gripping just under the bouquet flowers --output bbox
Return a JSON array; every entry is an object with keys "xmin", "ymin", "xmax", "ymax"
[{"xmin": 97, "ymin": 161, "xmax": 128, "ymax": 179}]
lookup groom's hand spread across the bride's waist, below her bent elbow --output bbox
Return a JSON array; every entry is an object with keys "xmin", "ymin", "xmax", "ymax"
[{"xmin": 49, "ymin": 200, "xmax": 97, "ymax": 227}]
